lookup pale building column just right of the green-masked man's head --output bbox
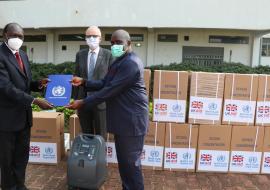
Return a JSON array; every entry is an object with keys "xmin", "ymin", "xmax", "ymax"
[{"xmin": 146, "ymin": 28, "xmax": 155, "ymax": 66}]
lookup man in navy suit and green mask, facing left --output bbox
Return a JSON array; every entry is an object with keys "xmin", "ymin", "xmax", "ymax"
[{"xmin": 67, "ymin": 30, "xmax": 148, "ymax": 190}]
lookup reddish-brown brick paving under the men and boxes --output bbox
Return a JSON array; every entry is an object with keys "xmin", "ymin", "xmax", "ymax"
[{"xmin": 23, "ymin": 161, "xmax": 270, "ymax": 190}]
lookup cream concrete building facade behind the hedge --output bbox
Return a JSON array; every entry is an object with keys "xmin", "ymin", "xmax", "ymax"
[{"xmin": 0, "ymin": 0, "xmax": 270, "ymax": 66}]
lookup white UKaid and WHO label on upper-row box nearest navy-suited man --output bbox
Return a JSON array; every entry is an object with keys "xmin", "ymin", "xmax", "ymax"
[{"xmin": 153, "ymin": 99, "xmax": 186, "ymax": 123}]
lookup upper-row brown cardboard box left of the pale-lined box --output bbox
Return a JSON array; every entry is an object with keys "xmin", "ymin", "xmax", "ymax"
[{"xmin": 153, "ymin": 70, "xmax": 188, "ymax": 123}]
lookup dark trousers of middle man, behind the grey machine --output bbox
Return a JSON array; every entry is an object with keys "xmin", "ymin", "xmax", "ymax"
[{"xmin": 78, "ymin": 109, "xmax": 107, "ymax": 139}]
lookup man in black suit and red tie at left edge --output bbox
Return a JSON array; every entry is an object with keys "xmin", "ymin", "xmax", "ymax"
[{"xmin": 0, "ymin": 23, "xmax": 52, "ymax": 190}]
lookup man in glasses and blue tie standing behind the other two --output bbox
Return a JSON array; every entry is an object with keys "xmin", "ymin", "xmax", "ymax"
[{"xmin": 74, "ymin": 26, "xmax": 113, "ymax": 139}]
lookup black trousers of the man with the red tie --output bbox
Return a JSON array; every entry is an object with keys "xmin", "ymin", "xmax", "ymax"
[{"xmin": 0, "ymin": 127, "xmax": 31, "ymax": 190}]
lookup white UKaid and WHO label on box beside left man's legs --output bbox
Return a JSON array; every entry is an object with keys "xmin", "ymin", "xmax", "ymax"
[{"xmin": 29, "ymin": 142, "xmax": 57, "ymax": 164}]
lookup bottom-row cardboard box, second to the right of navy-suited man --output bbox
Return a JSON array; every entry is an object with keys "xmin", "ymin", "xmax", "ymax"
[{"xmin": 164, "ymin": 123, "xmax": 198, "ymax": 172}]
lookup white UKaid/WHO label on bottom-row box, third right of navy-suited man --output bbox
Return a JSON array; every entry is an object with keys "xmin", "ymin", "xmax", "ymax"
[{"xmin": 197, "ymin": 150, "xmax": 230, "ymax": 172}]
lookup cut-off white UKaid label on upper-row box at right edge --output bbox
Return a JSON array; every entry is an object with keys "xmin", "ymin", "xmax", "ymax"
[{"xmin": 256, "ymin": 102, "xmax": 270, "ymax": 123}]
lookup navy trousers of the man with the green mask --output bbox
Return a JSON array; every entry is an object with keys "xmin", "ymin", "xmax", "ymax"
[{"xmin": 114, "ymin": 135, "xmax": 144, "ymax": 190}]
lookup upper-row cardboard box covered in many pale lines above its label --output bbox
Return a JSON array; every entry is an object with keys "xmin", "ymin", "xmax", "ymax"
[{"xmin": 188, "ymin": 72, "xmax": 225, "ymax": 124}]
